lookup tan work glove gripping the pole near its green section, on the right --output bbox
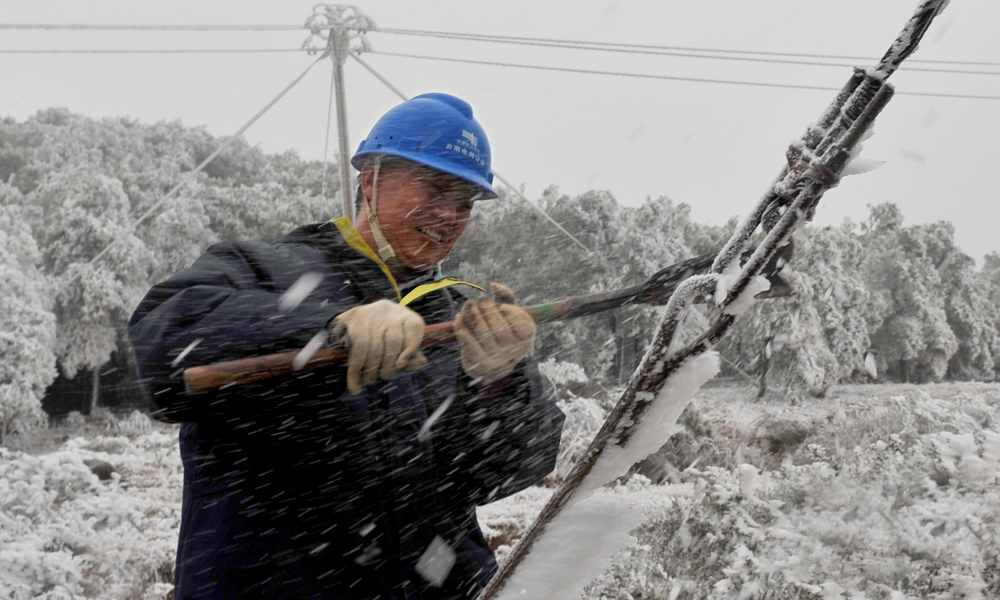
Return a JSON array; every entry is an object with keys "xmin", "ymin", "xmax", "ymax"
[{"xmin": 455, "ymin": 283, "xmax": 536, "ymax": 384}]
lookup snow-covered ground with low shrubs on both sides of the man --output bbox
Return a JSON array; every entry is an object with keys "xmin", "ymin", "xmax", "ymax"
[{"xmin": 0, "ymin": 383, "xmax": 1000, "ymax": 600}]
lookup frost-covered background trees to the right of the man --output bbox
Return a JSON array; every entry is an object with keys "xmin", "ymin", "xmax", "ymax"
[{"xmin": 450, "ymin": 188, "xmax": 1000, "ymax": 396}]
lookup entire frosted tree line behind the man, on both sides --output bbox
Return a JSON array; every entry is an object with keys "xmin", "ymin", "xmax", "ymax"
[{"xmin": 0, "ymin": 109, "xmax": 1000, "ymax": 435}]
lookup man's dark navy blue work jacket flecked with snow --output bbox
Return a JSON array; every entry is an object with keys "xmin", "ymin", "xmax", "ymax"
[{"xmin": 130, "ymin": 225, "xmax": 563, "ymax": 600}]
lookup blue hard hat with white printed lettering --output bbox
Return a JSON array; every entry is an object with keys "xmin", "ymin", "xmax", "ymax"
[{"xmin": 351, "ymin": 93, "xmax": 497, "ymax": 198}]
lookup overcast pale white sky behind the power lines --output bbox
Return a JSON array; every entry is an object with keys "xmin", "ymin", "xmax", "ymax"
[{"xmin": 0, "ymin": 0, "xmax": 1000, "ymax": 263}]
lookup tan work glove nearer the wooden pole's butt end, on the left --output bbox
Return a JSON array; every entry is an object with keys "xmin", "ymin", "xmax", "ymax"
[{"xmin": 329, "ymin": 300, "xmax": 427, "ymax": 394}]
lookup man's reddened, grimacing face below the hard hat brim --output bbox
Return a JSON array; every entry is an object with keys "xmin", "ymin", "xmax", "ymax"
[{"xmin": 361, "ymin": 163, "xmax": 480, "ymax": 271}]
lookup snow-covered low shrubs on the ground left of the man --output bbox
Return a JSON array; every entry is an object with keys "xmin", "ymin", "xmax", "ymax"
[{"xmin": 0, "ymin": 431, "xmax": 181, "ymax": 600}]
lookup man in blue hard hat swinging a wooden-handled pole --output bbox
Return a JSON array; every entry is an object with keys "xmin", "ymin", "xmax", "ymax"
[{"xmin": 130, "ymin": 94, "xmax": 563, "ymax": 600}]
